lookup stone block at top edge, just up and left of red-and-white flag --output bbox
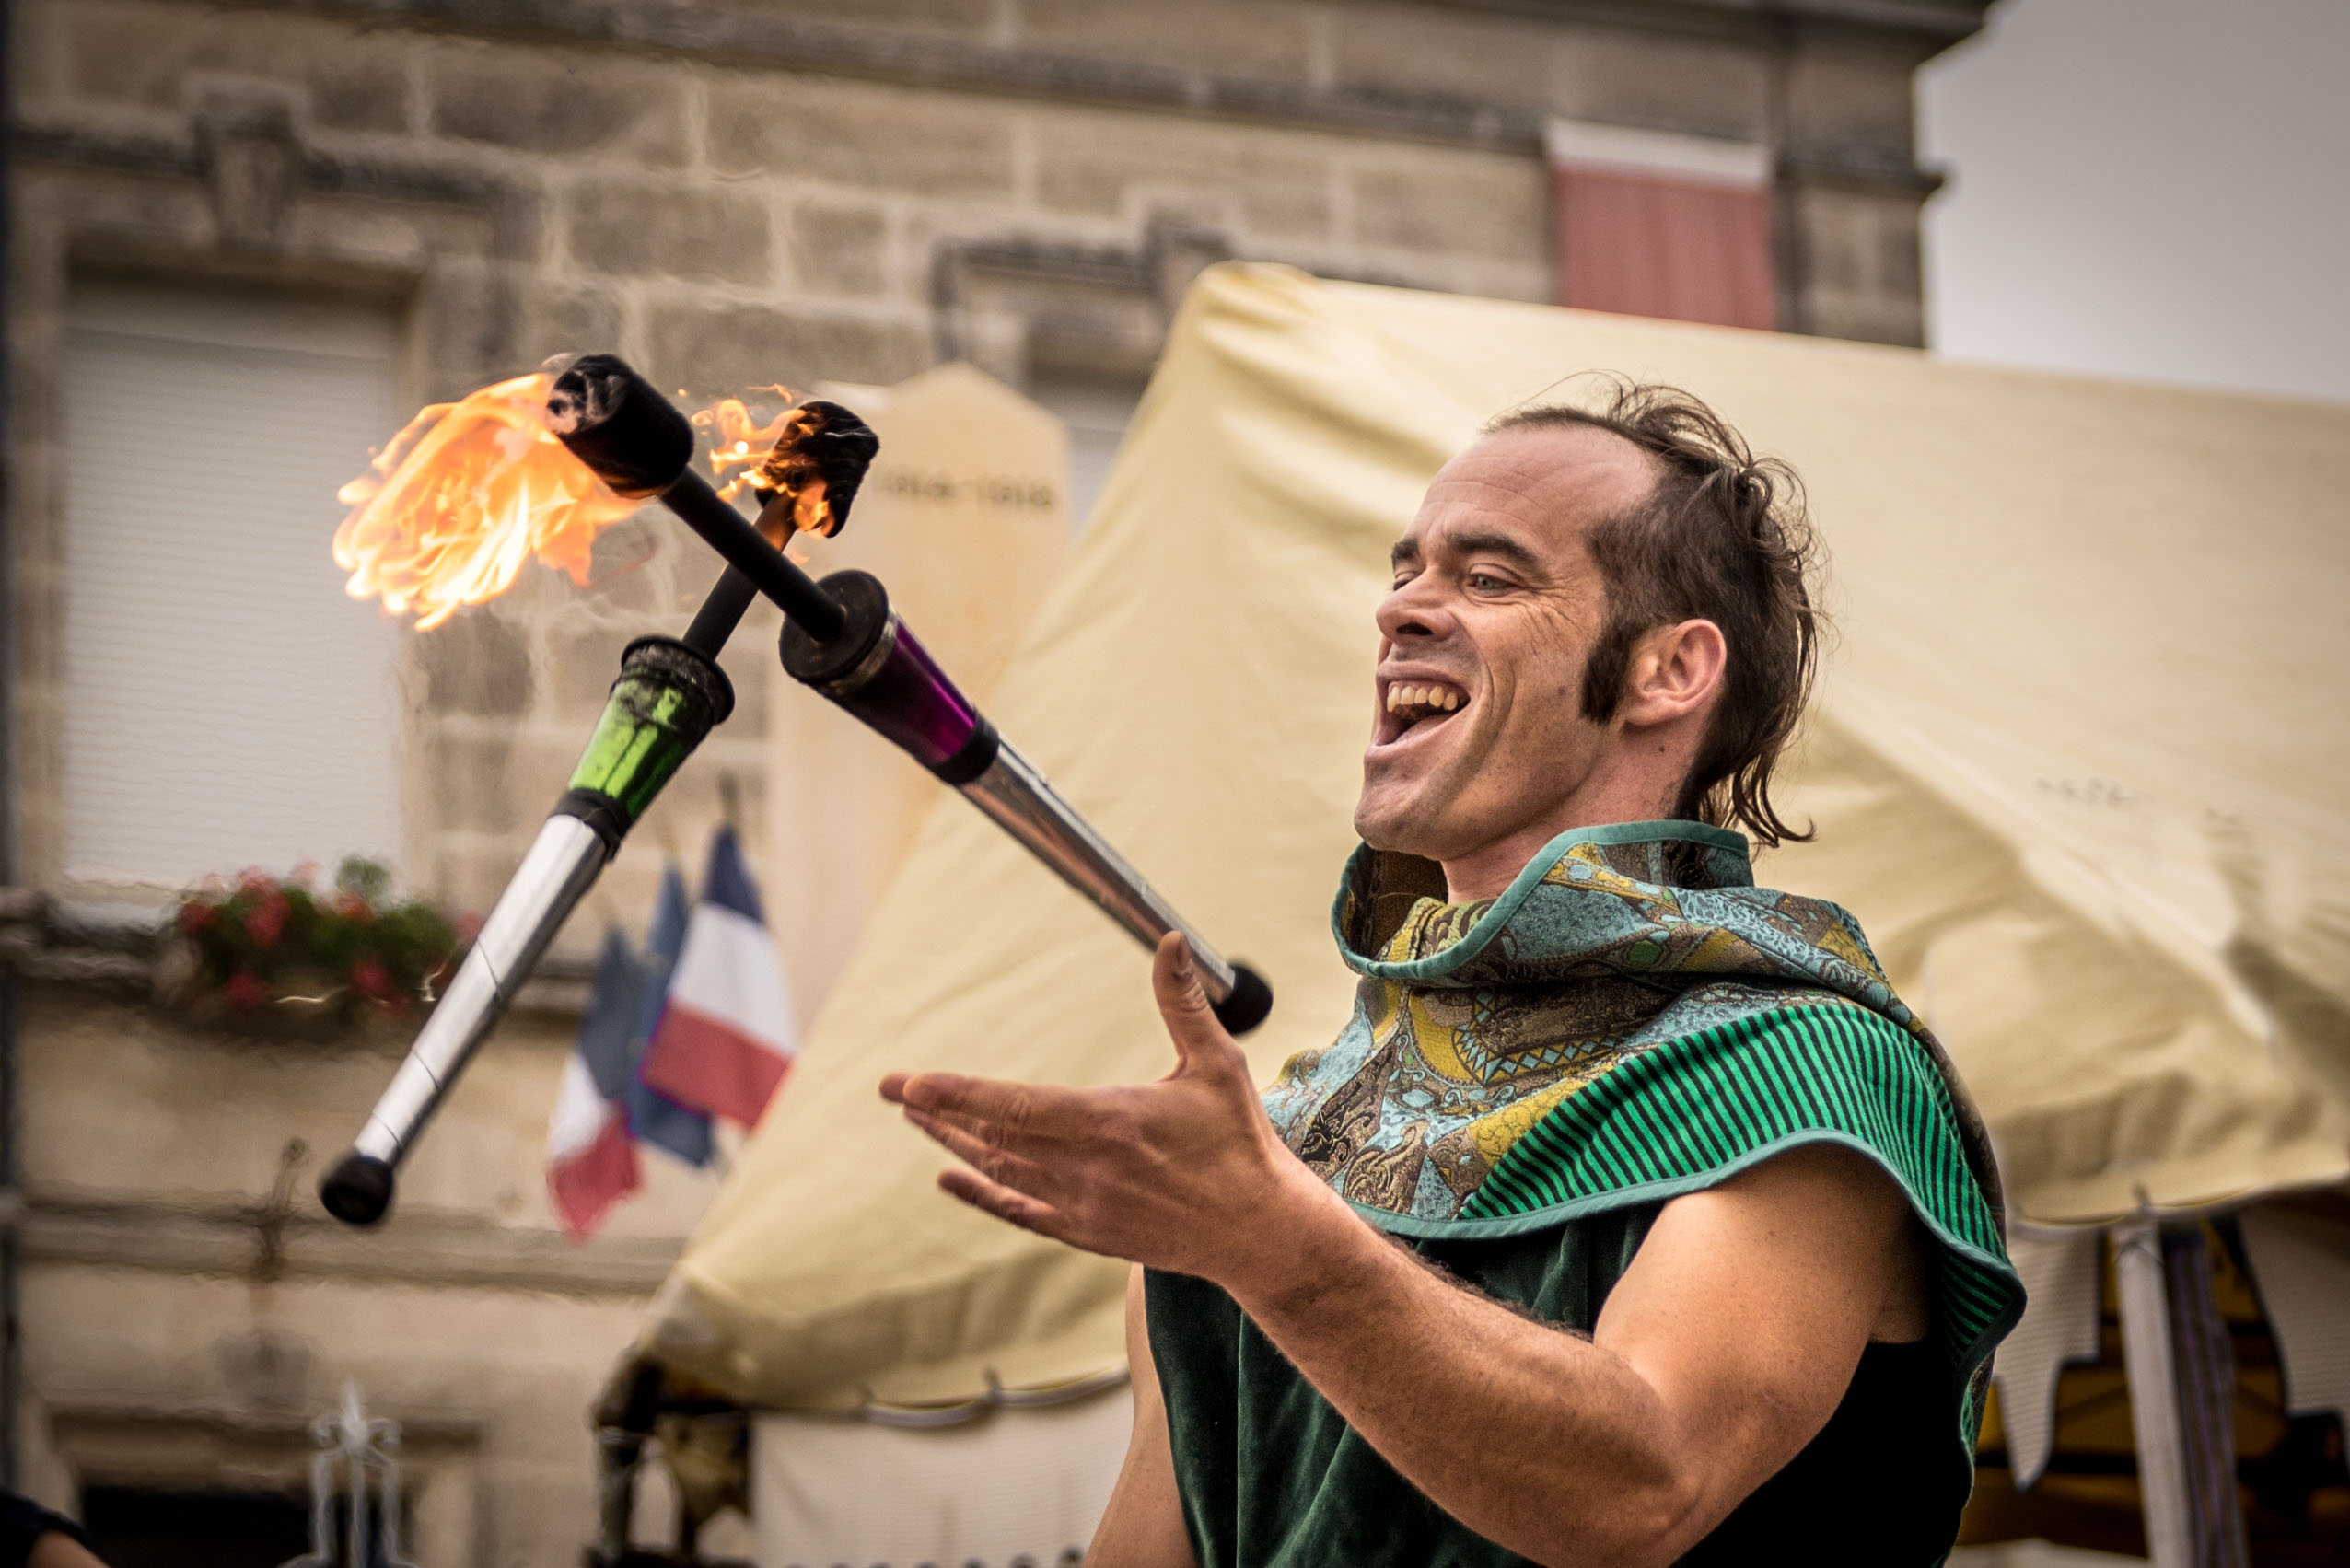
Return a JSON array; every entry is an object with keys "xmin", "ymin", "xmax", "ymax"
[{"xmin": 1330, "ymin": 5, "xmax": 1567, "ymax": 108}]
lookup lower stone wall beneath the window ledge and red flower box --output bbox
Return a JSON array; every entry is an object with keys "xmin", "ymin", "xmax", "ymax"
[{"xmin": 18, "ymin": 985, "xmax": 716, "ymax": 1568}]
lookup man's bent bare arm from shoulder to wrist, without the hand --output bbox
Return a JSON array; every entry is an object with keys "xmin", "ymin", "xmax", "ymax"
[{"xmin": 1234, "ymin": 1147, "xmax": 1906, "ymax": 1565}]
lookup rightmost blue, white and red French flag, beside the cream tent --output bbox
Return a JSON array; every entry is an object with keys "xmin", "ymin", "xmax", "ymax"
[{"xmin": 639, "ymin": 828, "xmax": 799, "ymax": 1126}]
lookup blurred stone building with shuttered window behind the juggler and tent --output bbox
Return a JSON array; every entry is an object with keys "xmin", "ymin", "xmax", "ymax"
[{"xmin": 0, "ymin": 0, "xmax": 2105, "ymax": 1568}]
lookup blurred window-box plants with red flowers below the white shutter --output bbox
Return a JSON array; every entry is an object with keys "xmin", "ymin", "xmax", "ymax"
[{"xmin": 174, "ymin": 855, "xmax": 470, "ymax": 1023}]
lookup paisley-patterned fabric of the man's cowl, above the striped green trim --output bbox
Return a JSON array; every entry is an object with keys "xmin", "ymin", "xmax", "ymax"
[{"xmin": 1264, "ymin": 823, "xmax": 1997, "ymax": 1232}]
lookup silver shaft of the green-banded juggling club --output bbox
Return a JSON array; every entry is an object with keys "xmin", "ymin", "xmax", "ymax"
[{"xmin": 353, "ymin": 816, "xmax": 604, "ymax": 1166}]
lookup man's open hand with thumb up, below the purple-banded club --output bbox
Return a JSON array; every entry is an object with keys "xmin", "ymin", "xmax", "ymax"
[{"xmin": 881, "ymin": 931, "xmax": 1361, "ymax": 1288}]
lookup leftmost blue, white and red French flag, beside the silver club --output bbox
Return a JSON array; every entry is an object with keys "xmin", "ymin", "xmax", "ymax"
[{"xmin": 548, "ymin": 926, "xmax": 644, "ymax": 1241}]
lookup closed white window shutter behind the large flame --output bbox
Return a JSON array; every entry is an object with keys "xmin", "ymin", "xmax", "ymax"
[{"xmin": 64, "ymin": 286, "xmax": 401, "ymax": 891}]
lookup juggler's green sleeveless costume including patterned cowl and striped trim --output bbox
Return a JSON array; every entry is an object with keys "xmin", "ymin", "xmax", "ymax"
[{"xmin": 1146, "ymin": 823, "xmax": 2023, "ymax": 1568}]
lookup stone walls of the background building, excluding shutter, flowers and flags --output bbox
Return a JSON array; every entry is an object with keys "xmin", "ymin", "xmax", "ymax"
[{"xmin": 7, "ymin": 0, "xmax": 1984, "ymax": 1568}]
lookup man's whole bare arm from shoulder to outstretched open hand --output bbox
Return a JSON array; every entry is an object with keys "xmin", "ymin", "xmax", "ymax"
[{"xmin": 884, "ymin": 938, "xmax": 1911, "ymax": 1568}]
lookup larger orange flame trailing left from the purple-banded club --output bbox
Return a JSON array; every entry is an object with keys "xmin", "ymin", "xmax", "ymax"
[{"xmin": 333, "ymin": 374, "xmax": 637, "ymax": 630}]
